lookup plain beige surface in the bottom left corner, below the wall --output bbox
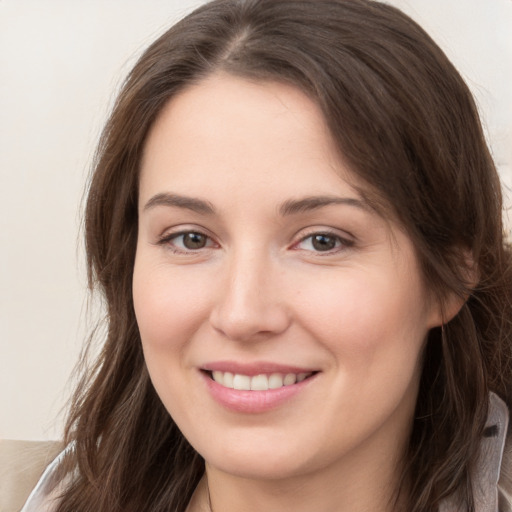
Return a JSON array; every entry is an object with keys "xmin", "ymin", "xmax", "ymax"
[{"xmin": 0, "ymin": 440, "xmax": 63, "ymax": 512}]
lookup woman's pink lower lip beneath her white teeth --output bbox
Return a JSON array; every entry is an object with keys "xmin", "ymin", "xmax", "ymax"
[{"xmin": 201, "ymin": 372, "xmax": 317, "ymax": 414}]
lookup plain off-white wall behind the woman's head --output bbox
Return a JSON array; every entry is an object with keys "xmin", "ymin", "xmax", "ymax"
[{"xmin": 0, "ymin": 0, "xmax": 512, "ymax": 439}]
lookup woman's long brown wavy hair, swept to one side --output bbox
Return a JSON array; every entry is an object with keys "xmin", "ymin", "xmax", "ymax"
[{"xmin": 58, "ymin": 0, "xmax": 512, "ymax": 512}]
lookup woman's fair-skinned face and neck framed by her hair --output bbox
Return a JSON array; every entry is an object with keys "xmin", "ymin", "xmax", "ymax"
[{"xmin": 133, "ymin": 74, "xmax": 441, "ymax": 512}]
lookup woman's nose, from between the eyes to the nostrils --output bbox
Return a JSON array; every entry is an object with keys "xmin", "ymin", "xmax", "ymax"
[{"xmin": 210, "ymin": 251, "xmax": 291, "ymax": 341}]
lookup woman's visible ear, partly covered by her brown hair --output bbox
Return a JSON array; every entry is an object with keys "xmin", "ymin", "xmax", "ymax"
[{"xmin": 431, "ymin": 249, "xmax": 479, "ymax": 327}]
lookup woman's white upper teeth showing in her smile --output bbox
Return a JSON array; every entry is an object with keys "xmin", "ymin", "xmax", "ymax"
[{"xmin": 212, "ymin": 371, "xmax": 312, "ymax": 391}]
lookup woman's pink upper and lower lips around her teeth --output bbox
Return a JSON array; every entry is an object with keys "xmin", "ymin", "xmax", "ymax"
[{"xmin": 200, "ymin": 361, "xmax": 317, "ymax": 414}]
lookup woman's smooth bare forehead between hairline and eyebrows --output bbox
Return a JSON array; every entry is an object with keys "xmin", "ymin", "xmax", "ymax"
[{"xmin": 140, "ymin": 74, "xmax": 384, "ymax": 217}]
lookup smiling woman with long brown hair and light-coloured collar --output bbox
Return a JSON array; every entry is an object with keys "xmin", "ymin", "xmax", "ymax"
[{"xmin": 22, "ymin": 0, "xmax": 512, "ymax": 512}]
